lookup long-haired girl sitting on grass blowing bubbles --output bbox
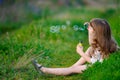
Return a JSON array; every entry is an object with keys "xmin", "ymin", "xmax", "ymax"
[{"xmin": 32, "ymin": 18, "xmax": 118, "ymax": 75}]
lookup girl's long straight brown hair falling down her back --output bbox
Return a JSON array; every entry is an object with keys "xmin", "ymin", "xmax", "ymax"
[{"xmin": 90, "ymin": 18, "xmax": 117, "ymax": 56}]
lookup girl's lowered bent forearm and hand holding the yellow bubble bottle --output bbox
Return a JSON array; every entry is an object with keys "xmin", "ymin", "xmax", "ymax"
[{"xmin": 76, "ymin": 45, "xmax": 91, "ymax": 63}]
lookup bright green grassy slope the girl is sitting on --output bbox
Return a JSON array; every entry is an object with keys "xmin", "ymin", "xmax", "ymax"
[{"xmin": 0, "ymin": 8, "xmax": 120, "ymax": 80}]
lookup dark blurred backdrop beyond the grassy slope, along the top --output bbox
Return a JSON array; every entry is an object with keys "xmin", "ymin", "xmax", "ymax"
[{"xmin": 0, "ymin": 0, "xmax": 119, "ymax": 34}]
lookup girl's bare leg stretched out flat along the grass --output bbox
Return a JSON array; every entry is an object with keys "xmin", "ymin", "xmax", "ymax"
[{"xmin": 41, "ymin": 65, "xmax": 86, "ymax": 75}]
